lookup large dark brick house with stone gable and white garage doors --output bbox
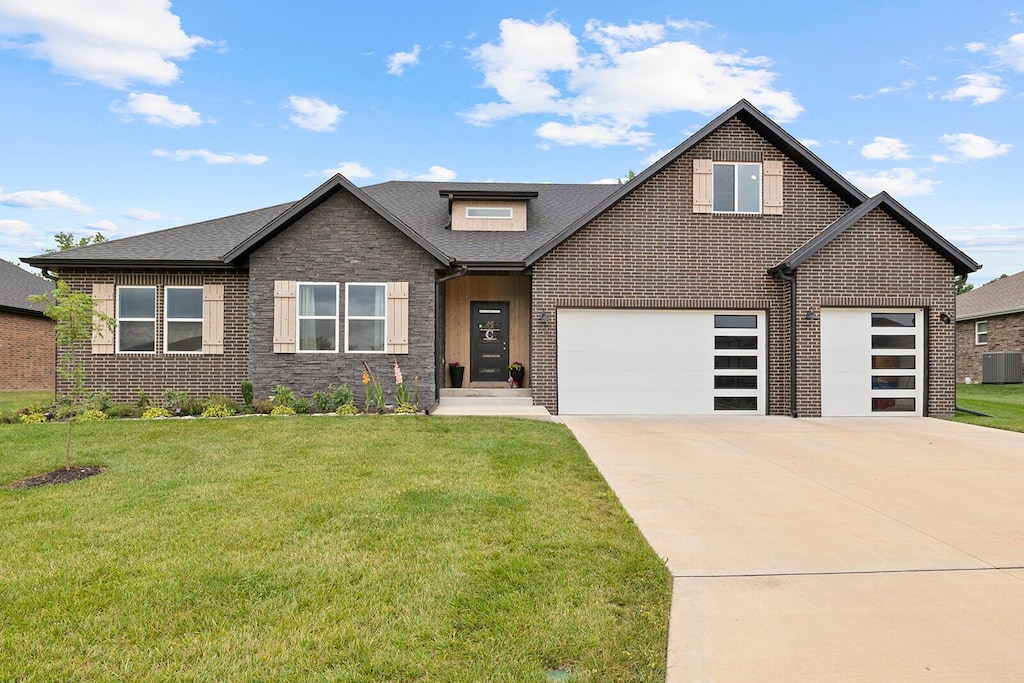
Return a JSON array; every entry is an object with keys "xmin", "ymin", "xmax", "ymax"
[{"xmin": 25, "ymin": 100, "xmax": 979, "ymax": 416}]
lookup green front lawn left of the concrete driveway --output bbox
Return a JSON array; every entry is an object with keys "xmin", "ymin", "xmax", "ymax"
[{"xmin": 0, "ymin": 417, "xmax": 671, "ymax": 682}]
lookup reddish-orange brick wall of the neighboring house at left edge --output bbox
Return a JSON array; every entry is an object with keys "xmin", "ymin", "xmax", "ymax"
[{"xmin": 0, "ymin": 310, "xmax": 55, "ymax": 391}]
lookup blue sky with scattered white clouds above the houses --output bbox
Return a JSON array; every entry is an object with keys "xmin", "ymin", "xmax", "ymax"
[{"xmin": 0, "ymin": 0, "xmax": 1024, "ymax": 283}]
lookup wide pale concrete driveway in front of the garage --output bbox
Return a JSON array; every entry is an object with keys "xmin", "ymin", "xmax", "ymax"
[{"xmin": 562, "ymin": 416, "xmax": 1024, "ymax": 682}]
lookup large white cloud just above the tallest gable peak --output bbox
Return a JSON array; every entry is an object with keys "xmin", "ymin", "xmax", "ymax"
[{"xmin": 463, "ymin": 18, "xmax": 803, "ymax": 145}]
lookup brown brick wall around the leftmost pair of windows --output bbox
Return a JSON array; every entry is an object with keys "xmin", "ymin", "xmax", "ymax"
[{"xmin": 54, "ymin": 268, "xmax": 249, "ymax": 402}]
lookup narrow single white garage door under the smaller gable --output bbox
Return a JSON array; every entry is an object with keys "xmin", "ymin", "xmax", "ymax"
[{"xmin": 821, "ymin": 308, "xmax": 925, "ymax": 417}]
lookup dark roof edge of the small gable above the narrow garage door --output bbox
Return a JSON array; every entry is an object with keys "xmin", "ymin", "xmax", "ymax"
[{"xmin": 768, "ymin": 193, "xmax": 981, "ymax": 275}]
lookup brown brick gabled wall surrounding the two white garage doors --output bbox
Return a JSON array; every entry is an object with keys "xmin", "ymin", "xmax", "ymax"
[{"xmin": 531, "ymin": 119, "xmax": 952, "ymax": 416}]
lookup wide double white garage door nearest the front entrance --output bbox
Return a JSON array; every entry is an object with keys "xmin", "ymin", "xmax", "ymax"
[{"xmin": 558, "ymin": 308, "xmax": 766, "ymax": 415}]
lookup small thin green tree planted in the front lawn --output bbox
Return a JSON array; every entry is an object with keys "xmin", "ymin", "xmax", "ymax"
[{"xmin": 29, "ymin": 281, "xmax": 114, "ymax": 470}]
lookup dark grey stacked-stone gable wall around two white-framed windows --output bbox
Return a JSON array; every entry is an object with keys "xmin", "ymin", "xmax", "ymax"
[{"xmin": 249, "ymin": 190, "xmax": 436, "ymax": 405}]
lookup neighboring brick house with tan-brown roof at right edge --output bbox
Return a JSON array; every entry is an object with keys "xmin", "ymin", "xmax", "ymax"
[{"xmin": 956, "ymin": 272, "xmax": 1024, "ymax": 382}]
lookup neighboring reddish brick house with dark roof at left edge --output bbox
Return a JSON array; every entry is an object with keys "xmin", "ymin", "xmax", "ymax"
[{"xmin": 0, "ymin": 260, "xmax": 56, "ymax": 391}]
